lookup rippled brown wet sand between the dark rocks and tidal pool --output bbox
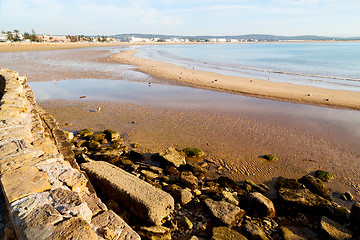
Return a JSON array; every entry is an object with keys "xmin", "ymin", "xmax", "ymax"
[{"xmin": 38, "ymin": 100, "xmax": 360, "ymax": 205}]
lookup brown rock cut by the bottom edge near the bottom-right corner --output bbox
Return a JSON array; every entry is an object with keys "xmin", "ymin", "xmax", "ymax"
[{"xmin": 320, "ymin": 216, "xmax": 352, "ymax": 240}]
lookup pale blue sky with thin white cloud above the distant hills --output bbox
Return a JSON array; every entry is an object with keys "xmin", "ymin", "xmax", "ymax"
[{"xmin": 0, "ymin": 0, "xmax": 360, "ymax": 37}]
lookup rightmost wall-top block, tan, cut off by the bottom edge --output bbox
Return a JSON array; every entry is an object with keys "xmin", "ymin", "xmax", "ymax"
[{"xmin": 91, "ymin": 210, "xmax": 140, "ymax": 240}]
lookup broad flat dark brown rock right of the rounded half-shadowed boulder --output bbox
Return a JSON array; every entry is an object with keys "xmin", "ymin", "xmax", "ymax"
[{"xmin": 278, "ymin": 188, "xmax": 332, "ymax": 213}]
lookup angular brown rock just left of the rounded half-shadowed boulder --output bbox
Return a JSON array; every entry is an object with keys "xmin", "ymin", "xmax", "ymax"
[{"xmin": 205, "ymin": 198, "xmax": 245, "ymax": 227}]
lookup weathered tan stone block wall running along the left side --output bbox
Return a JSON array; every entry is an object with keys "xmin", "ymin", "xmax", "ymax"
[{"xmin": 0, "ymin": 68, "xmax": 140, "ymax": 239}]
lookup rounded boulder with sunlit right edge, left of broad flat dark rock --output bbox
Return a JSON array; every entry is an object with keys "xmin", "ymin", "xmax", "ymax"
[{"xmin": 249, "ymin": 192, "xmax": 276, "ymax": 218}]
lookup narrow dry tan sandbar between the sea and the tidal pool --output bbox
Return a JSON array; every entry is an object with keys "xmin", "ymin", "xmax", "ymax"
[{"xmin": 108, "ymin": 50, "xmax": 360, "ymax": 110}]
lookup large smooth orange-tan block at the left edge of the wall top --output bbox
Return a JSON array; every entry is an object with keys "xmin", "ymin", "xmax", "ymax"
[{"xmin": 1, "ymin": 166, "xmax": 51, "ymax": 203}]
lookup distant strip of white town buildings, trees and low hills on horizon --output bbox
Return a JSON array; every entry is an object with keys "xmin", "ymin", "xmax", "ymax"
[{"xmin": 0, "ymin": 30, "xmax": 360, "ymax": 43}]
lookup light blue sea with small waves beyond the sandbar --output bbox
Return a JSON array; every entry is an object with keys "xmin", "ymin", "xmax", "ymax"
[{"xmin": 134, "ymin": 42, "xmax": 360, "ymax": 91}]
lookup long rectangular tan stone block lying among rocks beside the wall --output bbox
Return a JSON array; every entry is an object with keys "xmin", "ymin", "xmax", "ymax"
[{"xmin": 81, "ymin": 161, "xmax": 174, "ymax": 225}]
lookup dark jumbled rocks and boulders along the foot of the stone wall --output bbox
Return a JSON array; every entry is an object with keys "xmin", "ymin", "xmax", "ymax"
[{"xmin": 69, "ymin": 129, "xmax": 360, "ymax": 240}]
